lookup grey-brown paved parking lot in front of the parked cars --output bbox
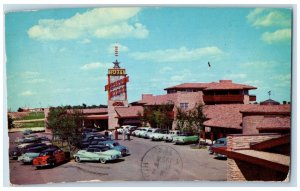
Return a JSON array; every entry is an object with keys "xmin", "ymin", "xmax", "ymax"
[{"xmin": 9, "ymin": 133, "xmax": 226, "ymax": 185}]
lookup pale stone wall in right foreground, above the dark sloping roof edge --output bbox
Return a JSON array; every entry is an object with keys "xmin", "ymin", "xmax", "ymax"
[{"xmin": 227, "ymin": 134, "xmax": 281, "ymax": 151}]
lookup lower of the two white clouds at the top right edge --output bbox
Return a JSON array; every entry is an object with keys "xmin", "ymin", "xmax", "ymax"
[{"xmin": 261, "ymin": 29, "xmax": 292, "ymax": 44}]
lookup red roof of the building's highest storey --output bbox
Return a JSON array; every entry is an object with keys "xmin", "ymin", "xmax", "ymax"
[{"xmin": 165, "ymin": 80, "xmax": 257, "ymax": 90}]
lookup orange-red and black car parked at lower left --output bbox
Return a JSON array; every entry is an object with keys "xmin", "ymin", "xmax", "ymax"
[{"xmin": 32, "ymin": 148, "xmax": 70, "ymax": 169}]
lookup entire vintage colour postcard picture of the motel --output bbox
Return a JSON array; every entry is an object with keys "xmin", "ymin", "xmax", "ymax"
[{"xmin": 4, "ymin": 6, "xmax": 293, "ymax": 186}]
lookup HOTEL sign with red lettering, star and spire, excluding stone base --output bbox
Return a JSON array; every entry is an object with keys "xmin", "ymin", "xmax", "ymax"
[{"xmin": 105, "ymin": 46, "xmax": 129, "ymax": 101}]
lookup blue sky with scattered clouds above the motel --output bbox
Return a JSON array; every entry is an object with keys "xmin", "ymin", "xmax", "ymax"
[{"xmin": 5, "ymin": 7, "xmax": 291, "ymax": 110}]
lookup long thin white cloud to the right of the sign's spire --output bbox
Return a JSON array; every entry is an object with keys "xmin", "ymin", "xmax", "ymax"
[{"xmin": 130, "ymin": 46, "xmax": 224, "ymax": 62}]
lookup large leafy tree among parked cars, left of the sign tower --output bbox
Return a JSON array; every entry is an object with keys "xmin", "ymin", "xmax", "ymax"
[{"xmin": 47, "ymin": 107, "xmax": 83, "ymax": 151}]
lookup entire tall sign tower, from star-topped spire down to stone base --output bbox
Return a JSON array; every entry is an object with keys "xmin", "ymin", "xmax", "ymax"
[{"xmin": 105, "ymin": 45, "xmax": 129, "ymax": 129}]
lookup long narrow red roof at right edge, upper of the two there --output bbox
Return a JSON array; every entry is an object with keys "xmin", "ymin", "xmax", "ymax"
[{"xmin": 241, "ymin": 104, "xmax": 291, "ymax": 114}]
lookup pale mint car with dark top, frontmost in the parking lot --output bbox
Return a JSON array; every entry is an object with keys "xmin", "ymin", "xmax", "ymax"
[{"xmin": 74, "ymin": 145, "xmax": 122, "ymax": 164}]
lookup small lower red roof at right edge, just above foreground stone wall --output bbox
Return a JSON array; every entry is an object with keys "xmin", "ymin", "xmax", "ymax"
[{"xmin": 257, "ymin": 116, "xmax": 291, "ymax": 130}]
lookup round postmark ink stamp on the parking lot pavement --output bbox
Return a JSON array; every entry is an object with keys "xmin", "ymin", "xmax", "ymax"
[{"xmin": 141, "ymin": 145, "xmax": 183, "ymax": 181}]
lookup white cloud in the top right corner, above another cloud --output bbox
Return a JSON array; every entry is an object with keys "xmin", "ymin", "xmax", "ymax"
[{"xmin": 247, "ymin": 8, "xmax": 291, "ymax": 27}]
